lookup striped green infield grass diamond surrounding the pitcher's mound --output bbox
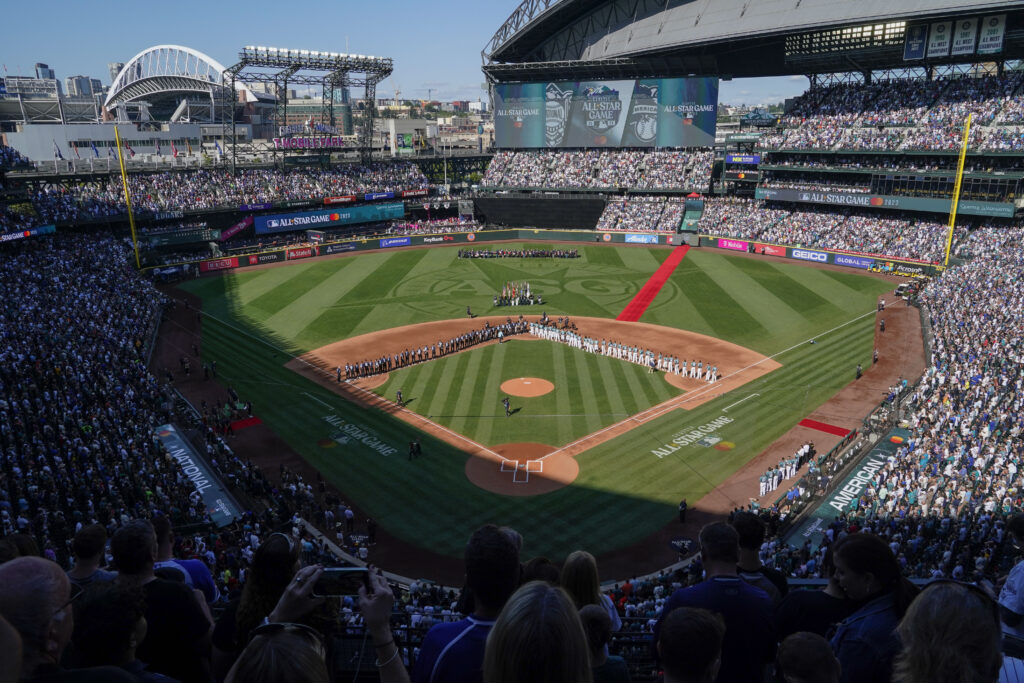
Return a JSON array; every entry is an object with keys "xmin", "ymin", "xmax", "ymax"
[{"xmin": 376, "ymin": 339, "xmax": 683, "ymax": 445}]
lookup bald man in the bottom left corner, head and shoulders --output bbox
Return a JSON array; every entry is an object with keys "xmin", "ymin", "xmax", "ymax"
[{"xmin": 0, "ymin": 557, "xmax": 135, "ymax": 683}]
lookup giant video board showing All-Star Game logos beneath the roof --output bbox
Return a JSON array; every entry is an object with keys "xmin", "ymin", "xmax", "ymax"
[{"xmin": 495, "ymin": 78, "xmax": 718, "ymax": 147}]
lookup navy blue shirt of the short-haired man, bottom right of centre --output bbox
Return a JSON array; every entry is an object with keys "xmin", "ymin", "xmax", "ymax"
[{"xmin": 654, "ymin": 577, "xmax": 775, "ymax": 683}]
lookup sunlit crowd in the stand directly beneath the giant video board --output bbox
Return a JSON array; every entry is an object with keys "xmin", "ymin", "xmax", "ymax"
[{"xmin": 480, "ymin": 150, "xmax": 714, "ymax": 191}]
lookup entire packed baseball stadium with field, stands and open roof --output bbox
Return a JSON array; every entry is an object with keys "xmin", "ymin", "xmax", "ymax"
[{"xmin": 0, "ymin": 0, "xmax": 1024, "ymax": 683}]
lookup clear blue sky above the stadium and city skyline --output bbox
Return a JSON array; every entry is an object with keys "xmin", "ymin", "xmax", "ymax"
[{"xmin": 0, "ymin": 0, "xmax": 807, "ymax": 104}]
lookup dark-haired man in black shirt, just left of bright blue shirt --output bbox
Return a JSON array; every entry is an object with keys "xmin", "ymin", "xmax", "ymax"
[{"xmin": 111, "ymin": 519, "xmax": 211, "ymax": 683}]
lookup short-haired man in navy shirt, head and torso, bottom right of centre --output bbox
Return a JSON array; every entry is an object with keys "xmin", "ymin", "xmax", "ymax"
[{"xmin": 654, "ymin": 522, "xmax": 775, "ymax": 683}]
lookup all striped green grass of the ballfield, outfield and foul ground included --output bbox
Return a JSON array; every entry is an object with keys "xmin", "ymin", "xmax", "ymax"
[{"xmin": 183, "ymin": 245, "xmax": 892, "ymax": 558}]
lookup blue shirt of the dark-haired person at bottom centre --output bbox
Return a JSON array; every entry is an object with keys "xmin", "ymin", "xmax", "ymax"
[{"xmin": 413, "ymin": 616, "xmax": 495, "ymax": 683}]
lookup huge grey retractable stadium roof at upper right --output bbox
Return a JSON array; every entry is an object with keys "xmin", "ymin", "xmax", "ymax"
[{"xmin": 482, "ymin": 0, "xmax": 1024, "ymax": 81}]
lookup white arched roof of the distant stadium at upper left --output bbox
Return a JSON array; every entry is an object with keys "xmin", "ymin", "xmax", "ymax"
[{"xmin": 103, "ymin": 45, "xmax": 245, "ymax": 111}]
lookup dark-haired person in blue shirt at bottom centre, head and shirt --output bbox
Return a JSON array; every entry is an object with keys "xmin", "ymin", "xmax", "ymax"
[{"xmin": 413, "ymin": 524, "xmax": 520, "ymax": 683}]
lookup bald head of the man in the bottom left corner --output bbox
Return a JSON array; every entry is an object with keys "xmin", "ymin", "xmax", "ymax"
[{"xmin": 0, "ymin": 557, "xmax": 74, "ymax": 674}]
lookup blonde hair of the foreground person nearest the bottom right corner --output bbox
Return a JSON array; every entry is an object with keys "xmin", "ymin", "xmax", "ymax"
[{"xmin": 893, "ymin": 582, "xmax": 1002, "ymax": 683}]
